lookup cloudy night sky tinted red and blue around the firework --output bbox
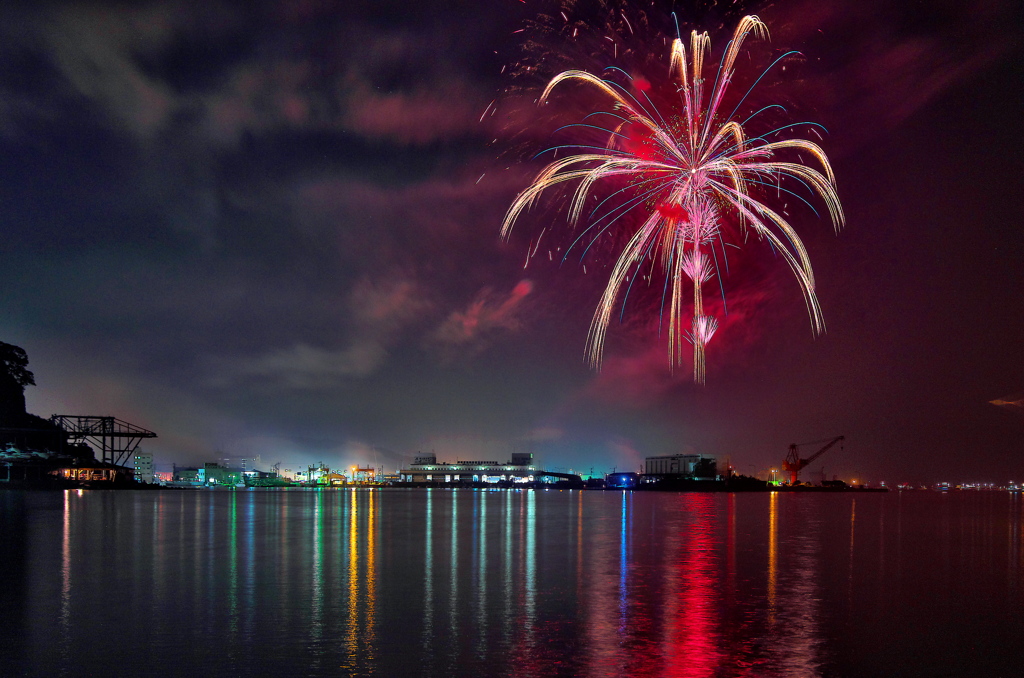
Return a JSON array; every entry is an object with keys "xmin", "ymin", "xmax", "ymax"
[{"xmin": 0, "ymin": 0, "xmax": 1024, "ymax": 483}]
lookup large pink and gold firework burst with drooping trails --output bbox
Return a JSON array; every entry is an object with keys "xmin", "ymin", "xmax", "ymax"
[{"xmin": 502, "ymin": 16, "xmax": 843, "ymax": 383}]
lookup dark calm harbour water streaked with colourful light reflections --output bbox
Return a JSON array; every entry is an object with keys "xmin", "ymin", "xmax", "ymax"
[{"xmin": 0, "ymin": 490, "xmax": 1024, "ymax": 677}]
